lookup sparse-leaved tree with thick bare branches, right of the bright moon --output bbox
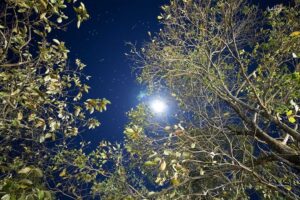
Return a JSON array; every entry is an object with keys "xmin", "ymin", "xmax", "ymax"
[{"xmin": 121, "ymin": 0, "xmax": 300, "ymax": 199}]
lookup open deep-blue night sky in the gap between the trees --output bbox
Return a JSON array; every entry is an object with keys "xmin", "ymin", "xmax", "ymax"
[{"xmin": 58, "ymin": 0, "xmax": 288, "ymax": 146}]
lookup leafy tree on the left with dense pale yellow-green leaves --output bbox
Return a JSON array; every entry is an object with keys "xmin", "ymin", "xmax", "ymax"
[{"xmin": 0, "ymin": 0, "xmax": 115, "ymax": 200}]
